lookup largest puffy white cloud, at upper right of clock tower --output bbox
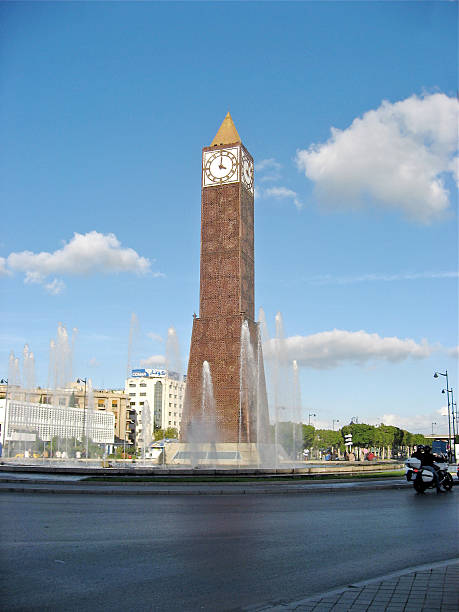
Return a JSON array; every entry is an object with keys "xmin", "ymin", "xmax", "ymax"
[{"xmin": 296, "ymin": 93, "xmax": 458, "ymax": 223}]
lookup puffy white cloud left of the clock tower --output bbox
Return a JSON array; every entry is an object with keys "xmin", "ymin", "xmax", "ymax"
[{"xmin": 0, "ymin": 231, "xmax": 160, "ymax": 295}]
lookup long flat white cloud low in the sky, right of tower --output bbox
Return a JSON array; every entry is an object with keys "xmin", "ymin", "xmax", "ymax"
[{"xmin": 263, "ymin": 329, "xmax": 433, "ymax": 370}]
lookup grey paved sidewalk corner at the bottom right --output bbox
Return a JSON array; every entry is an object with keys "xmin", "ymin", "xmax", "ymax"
[{"xmin": 245, "ymin": 559, "xmax": 459, "ymax": 612}]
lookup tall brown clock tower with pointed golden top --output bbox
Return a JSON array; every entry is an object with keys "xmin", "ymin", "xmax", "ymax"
[{"xmin": 181, "ymin": 113, "xmax": 268, "ymax": 443}]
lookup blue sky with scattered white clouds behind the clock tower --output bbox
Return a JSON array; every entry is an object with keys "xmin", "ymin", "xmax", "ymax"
[{"xmin": 0, "ymin": 2, "xmax": 458, "ymax": 432}]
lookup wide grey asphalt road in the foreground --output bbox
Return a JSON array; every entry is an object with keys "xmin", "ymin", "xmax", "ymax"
[{"xmin": 0, "ymin": 488, "xmax": 459, "ymax": 612}]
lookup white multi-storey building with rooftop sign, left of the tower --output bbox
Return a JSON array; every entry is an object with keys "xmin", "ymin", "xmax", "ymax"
[{"xmin": 125, "ymin": 369, "xmax": 186, "ymax": 445}]
